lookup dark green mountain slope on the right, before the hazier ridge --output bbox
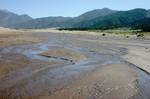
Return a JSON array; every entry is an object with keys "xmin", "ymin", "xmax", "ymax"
[{"xmin": 73, "ymin": 9, "xmax": 148, "ymax": 28}]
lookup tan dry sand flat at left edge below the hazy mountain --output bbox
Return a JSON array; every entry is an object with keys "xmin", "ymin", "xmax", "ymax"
[{"xmin": 0, "ymin": 28, "xmax": 46, "ymax": 47}]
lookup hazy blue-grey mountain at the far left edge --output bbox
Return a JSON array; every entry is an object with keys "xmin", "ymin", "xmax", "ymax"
[{"xmin": 0, "ymin": 10, "xmax": 32, "ymax": 27}]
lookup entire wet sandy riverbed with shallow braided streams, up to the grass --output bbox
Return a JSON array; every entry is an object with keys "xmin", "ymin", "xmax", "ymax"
[{"xmin": 0, "ymin": 30, "xmax": 150, "ymax": 99}]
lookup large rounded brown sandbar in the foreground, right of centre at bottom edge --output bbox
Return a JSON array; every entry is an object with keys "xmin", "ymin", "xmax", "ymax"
[{"xmin": 41, "ymin": 64, "xmax": 138, "ymax": 99}]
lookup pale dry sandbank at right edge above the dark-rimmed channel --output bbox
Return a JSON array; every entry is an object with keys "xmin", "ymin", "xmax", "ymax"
[{"xmin": 123, "ymin": 47, "xmax": 150, "ymax": 73}]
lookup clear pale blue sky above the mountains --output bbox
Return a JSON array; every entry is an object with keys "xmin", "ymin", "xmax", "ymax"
[{"xmin": 0, "ymin": 0, "xmax": 150, "ymax": 18}]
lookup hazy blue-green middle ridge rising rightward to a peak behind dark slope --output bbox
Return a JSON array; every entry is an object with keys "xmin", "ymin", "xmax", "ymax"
[{"xmin": 15, "ymin": 8, "xmax": 116, "ymax": 28}]
